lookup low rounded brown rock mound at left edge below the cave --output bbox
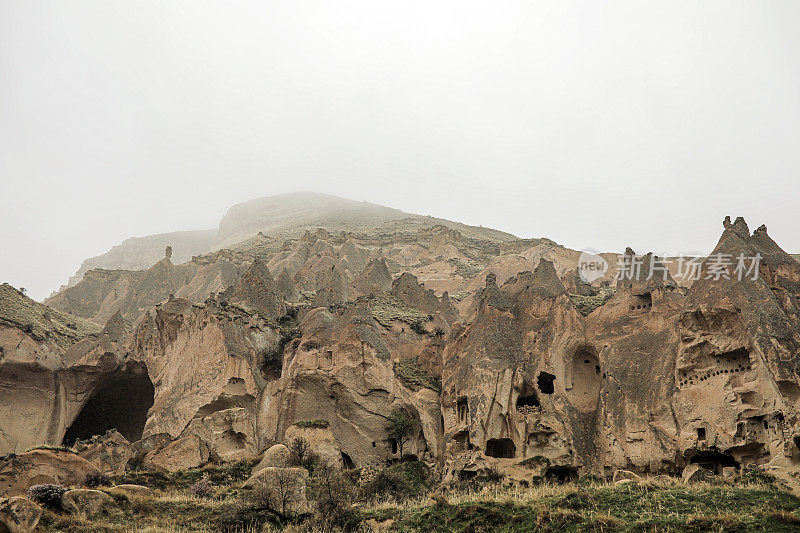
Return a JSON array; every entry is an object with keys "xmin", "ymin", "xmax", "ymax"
[{"xmin": 0, "ymin": 449, "xmax": 97, "ymax": 497}]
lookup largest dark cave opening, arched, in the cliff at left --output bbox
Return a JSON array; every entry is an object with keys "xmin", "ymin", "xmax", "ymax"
[{"xmin": 62, "ymin": 361, "xmax": 155, "ymax": 446}]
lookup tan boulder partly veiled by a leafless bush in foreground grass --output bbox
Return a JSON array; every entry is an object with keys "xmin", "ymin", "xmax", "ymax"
[{"xmin": 242, "ymin": 466, "xmax": 310, "ymax": 515}]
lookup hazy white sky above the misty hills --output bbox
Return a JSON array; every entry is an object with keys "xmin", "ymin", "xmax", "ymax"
[{"xmin": 0, "ymin": 0, "xmax": 800, "ymax": 298}]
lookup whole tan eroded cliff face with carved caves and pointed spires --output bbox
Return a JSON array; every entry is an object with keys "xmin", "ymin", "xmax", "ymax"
[{"xmin": 0, "ymin": 214, "xmax": 800, "ymax": 496}]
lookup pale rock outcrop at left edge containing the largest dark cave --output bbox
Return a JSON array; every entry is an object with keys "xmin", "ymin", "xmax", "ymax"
[{"xmin": 0, "ymin": 286, "xmax": 152, "ymax": 453}]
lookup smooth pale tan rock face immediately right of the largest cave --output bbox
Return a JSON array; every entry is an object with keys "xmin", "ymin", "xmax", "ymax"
[{"xmin": 132, "ymin": 298, "xmax": 280, "ymax": 437}]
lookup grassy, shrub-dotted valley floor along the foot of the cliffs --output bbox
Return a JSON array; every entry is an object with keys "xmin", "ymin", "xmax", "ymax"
[{"xmin": 34, "ymin": 464, "xmax": 800, "ymax": 533}]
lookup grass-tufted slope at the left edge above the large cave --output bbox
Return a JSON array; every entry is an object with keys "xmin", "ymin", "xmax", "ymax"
[{"xmin": 0, "ymin": 283, "xmax": 103, "ymax": 348}]
